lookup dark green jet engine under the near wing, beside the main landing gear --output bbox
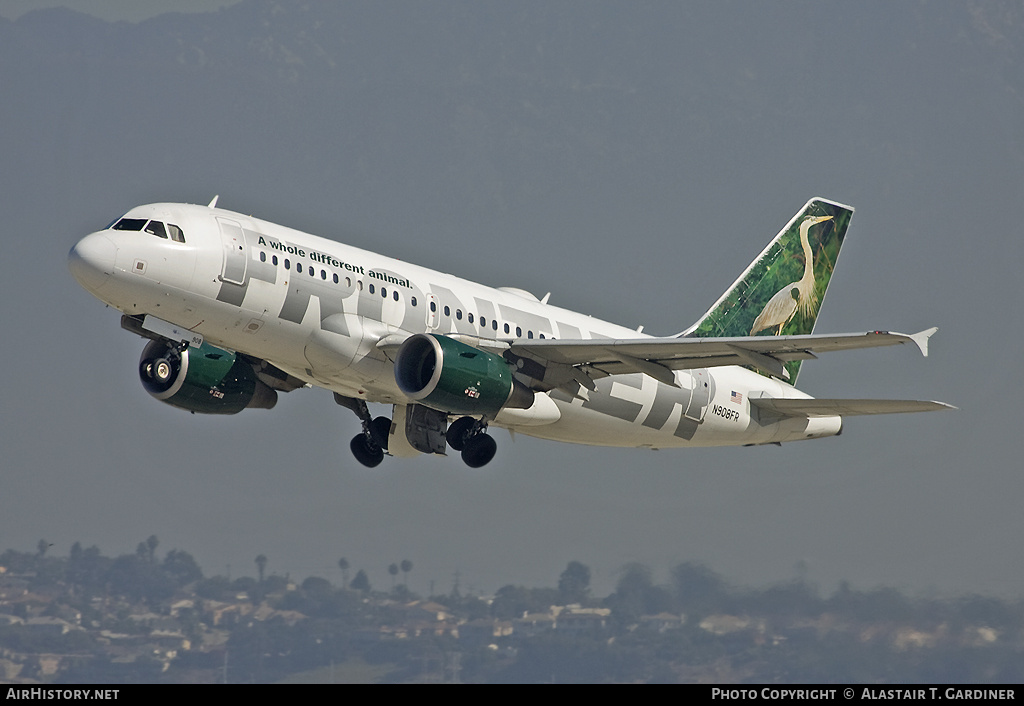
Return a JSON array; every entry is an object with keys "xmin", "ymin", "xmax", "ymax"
[{"xmin": 394, "ymin": 333, "xmax": 534, "ymax": 418}]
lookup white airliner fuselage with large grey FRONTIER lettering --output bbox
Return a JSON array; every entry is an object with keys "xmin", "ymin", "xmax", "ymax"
[{"xmin": 70, "ymin": 203, "xmax": 841, "ymax": 448}]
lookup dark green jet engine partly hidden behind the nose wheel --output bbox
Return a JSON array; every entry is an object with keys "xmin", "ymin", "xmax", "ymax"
[{"xmin": 138, "ymin": 340, "xmax": 278, "ymax": 414}]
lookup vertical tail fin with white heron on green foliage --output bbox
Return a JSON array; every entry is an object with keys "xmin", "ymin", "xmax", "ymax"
[{"xmin": 681, "ymin": 198, "xmax": 853, "ymax": 383}]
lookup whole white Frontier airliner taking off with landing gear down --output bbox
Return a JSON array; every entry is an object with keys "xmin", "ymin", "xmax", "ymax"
[{"xmin": 69, "ymin": 197, "xmax": 953, "ymax": 468}]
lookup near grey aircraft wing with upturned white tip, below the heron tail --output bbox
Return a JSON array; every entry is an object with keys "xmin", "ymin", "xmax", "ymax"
[{"xmin": 509, "ymin": 328, "xmax": 938, "ymax": 384}]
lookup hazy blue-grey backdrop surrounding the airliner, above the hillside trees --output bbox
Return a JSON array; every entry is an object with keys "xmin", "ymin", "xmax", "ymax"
[{"xmin": 0, "ymin": 0, "xmax": 1024, "ymax": 595}]
